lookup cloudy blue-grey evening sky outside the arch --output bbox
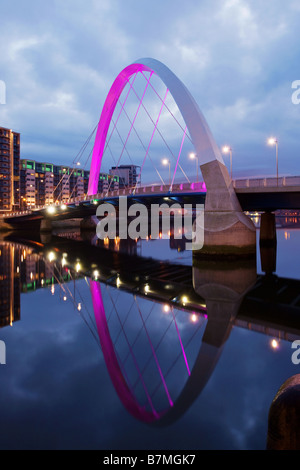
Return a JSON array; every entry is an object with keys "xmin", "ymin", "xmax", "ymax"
[{"xmin": 0, "ymin": 0, "xmax": 300, "ymax": 180}]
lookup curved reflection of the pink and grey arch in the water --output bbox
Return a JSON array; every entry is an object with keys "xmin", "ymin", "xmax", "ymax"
[{"xmin": 90, "ymin": 280, "xmax": 223, "ymax": 425}]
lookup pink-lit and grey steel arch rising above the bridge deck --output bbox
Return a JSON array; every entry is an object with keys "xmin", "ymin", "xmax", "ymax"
[{"xmin": 88, "ymin": 59, "xmax": 224, "ymax": 195}]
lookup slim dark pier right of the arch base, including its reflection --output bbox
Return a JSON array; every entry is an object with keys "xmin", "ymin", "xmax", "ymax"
[{"xmin": 259, "ymin": 212, "xmax": 277, "ymax": 274}]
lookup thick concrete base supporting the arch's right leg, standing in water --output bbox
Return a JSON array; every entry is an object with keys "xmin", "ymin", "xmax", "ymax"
[{"xmin": 199, "ymin": 160, "xmax": 256, "ymax": 257}]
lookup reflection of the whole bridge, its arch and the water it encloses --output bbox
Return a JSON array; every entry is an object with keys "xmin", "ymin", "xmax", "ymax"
[{"xmin": 0, "ymin": 224, "xmax": 300, "ymax": 434}]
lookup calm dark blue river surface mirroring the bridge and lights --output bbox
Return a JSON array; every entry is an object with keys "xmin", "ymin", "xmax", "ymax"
[{"xmin": 0, "ymin": 218, "xmax": 300, "ymax": 450}]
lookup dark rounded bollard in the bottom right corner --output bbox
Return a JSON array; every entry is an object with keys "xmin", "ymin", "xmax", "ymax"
[{"xmin": 267, "ymin": 374, "xmax": 300, "ymax": 450}]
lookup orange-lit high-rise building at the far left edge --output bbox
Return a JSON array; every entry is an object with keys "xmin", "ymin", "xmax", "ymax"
[{"xmin": 0, "ymin": 127, "xmax": 20, "ymax": 211}]
